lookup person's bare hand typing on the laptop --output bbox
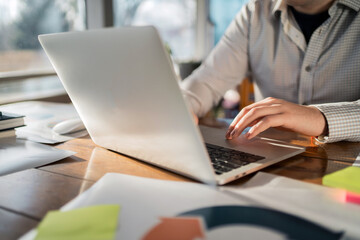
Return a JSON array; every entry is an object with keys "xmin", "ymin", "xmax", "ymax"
[{"xmin": 226, "ymin": 97, "xmax": 326, "ymax": 139}]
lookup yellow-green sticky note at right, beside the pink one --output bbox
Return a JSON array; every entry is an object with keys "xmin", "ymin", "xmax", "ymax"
[{"xmin": 323, "ymin": 167, "xmax": 360, "ymax": 193}]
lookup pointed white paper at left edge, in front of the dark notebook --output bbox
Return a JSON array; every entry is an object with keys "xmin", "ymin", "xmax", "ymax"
[{"xmin": 0, "ymin": 138, "xmax": 75, "ymax": 176}]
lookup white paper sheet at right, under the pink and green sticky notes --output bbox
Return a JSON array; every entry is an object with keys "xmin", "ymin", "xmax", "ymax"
[{"xmin": 222, "ymin": 172, "xmax": 360, "ymax": 239}]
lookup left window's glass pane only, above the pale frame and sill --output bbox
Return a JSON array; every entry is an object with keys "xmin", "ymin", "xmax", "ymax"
[{"xmin": 0, "ymin": 0, "xmax": 85, "ymax": 72}]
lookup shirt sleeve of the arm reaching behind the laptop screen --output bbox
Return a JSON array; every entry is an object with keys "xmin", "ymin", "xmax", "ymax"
[{"xmin": 180, "ymin": 4, "xmax": 251, "ymax": 117}]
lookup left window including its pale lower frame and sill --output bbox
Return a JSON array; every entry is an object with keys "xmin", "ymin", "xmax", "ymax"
[{"xmin": 0, "ymin": 0, "xmax": 85, "ymax": 104}]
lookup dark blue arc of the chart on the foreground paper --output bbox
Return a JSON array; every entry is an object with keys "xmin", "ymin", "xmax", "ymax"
[{"xmin": 177, "ymin": 206, "xmax": 344, "ymax": 240}]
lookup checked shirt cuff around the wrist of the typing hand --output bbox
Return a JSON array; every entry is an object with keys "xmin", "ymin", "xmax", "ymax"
[{"xmin": 313, "ymin": 100, "xmax": 360, "ymax": 143}]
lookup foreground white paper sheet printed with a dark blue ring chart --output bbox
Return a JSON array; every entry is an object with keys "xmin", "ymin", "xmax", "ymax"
[{"xmin": 22, "ymin": 173, "xmax": 348, "ymax": 240}]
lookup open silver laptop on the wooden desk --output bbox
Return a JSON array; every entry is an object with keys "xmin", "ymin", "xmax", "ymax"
[{"xmin": 39, "ymin": 26, "xmax": 304, "ymax": 185}]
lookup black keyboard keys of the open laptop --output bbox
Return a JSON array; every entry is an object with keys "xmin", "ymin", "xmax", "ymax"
[{"xmin": 205, "ymin": 143, "xmax": 265, "ymax": 175}]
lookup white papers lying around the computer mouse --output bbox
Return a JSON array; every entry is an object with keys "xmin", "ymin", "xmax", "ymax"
[{"xmin": 0, "ymin": 101, "xmax": 87, "ymax": 144}]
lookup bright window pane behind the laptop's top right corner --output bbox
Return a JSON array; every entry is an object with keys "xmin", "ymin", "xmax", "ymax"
[{"xmin": 114, "ymin": 0, "xmax": 196, "ymax": 61}]
